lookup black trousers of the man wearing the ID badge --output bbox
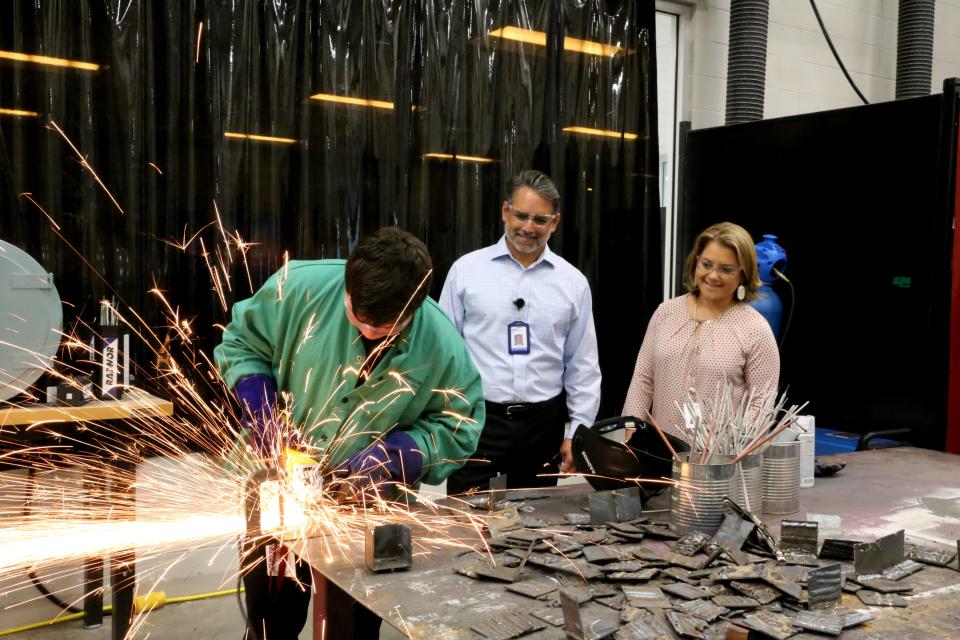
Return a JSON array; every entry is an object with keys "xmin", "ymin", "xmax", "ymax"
[{"xmin": 447, "ymin": 394, "xmax": 568, "ymax": 495}]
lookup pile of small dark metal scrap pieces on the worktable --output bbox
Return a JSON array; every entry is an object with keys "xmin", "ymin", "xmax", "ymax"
[{"xmin": 456, "ymin": 492, "xmax": 952, "ymax": 640}]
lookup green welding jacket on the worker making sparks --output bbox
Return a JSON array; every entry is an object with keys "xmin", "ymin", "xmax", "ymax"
[{"xmin": 214, "ymin": 260, "xmax": 484, "ymax": 484}]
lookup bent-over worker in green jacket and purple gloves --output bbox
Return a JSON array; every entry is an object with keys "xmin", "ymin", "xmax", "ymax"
[{"xmin": 214, "ymin": 227, "xmax": 484, "ymax": 640}]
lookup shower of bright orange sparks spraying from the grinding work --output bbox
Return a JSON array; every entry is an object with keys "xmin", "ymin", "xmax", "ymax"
[{"xmin": 0, "ymin": 194, "xmax": 502, "ymax": 636}]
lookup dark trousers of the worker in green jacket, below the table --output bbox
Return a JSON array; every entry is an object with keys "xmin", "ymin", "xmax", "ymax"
[{"xmin": 240, "ymin": 543, "xmax": 380, "ymax": 640}]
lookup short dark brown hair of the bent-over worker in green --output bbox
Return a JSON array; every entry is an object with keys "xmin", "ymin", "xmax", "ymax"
[{"xmin": 346, "ymin": 227, "xmax": 433, "ymax": 327}]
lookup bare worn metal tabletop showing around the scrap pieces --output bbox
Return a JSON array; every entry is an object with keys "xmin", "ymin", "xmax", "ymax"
[{"xmin": 300, "ymin": 447, "xmax": 960, "ymax": 639}]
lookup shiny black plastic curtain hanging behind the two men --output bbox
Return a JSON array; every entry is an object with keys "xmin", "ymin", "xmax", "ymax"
[{"xmin": 0, "ymin": 0, "xmax": 661, "ymax": 414}]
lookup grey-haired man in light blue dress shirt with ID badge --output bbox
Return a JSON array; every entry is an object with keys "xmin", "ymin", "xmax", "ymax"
[{"xmin": 440, "ymin": 170, "xmax": 600, "ymax": 494}]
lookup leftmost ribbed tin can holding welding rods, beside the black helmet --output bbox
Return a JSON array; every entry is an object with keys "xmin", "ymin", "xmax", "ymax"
[{"xmin": 670, "ymin": 453, "xmax": 736, "ymax": 535}]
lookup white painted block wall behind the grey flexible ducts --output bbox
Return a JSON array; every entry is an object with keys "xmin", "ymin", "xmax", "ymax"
[{"xmin": 681, "ymin": 0, "xmax": 960, "ymax": 128}]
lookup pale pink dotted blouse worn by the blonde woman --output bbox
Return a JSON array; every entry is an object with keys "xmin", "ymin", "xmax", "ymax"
[{"xmin": 621, "ymin": 294, "xmax": 780, "ymax": 440}]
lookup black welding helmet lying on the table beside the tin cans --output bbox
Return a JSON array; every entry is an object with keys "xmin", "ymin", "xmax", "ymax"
[{"xmin": 573, "ymin": 416, "xmax": 690, "ymax": 499}]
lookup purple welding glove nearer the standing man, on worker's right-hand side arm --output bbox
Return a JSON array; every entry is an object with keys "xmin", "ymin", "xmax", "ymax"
[{"xmin": 335, "ymin": 431, "xmax": 422, "ymax": 502}]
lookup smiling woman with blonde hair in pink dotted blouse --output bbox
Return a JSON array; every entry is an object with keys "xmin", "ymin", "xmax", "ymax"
[{"xmin": 621, "ymin": 222, "xmax": 780, "ymax": 441}]
